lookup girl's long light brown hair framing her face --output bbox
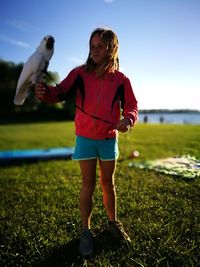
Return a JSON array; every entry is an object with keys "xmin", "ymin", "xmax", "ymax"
[{"xmin": 85, "ymin": 28, "xmax": 119, "ymax": 77}]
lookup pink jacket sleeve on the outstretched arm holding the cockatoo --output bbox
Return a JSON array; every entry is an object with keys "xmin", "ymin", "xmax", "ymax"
[{"xmin": 39, "ymin": 67, "xmax": 80, "ymax": 103}]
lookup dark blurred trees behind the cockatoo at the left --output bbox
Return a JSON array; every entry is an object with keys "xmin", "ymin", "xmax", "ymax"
[{"xmin": 0, "ymin": 60, "xmax": 75, "ymax": 122}]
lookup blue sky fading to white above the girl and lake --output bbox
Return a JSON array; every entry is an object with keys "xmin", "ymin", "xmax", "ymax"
[{"xmin": 0, "ymin": 0, "xmax": 200, "ymax": 110}]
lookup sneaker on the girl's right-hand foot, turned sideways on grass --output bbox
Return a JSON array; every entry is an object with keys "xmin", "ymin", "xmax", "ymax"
[{"xmin": 105, "ymin": 221, "xmax": 131, "ymax": 245}]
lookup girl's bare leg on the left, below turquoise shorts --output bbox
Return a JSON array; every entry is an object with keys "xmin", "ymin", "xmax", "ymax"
[{"xmin": 79, "ymin": 159, "xmax": 97, "ymax": 229}]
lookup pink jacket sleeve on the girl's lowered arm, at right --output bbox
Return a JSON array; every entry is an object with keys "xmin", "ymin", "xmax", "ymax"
[{"xmin": 122, "ymin": 77, "xmax": 138, "ymax": 127}]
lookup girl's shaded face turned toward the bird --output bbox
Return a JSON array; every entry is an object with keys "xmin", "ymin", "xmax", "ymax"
[{"xmin": 90, "ymin": 34, "xmax": 107, "ymax": 65}]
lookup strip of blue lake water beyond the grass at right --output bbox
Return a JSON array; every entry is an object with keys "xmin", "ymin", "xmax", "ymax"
[{"xmin": 139, "ymin": 112, "xmax": 200, "ymax": 124}]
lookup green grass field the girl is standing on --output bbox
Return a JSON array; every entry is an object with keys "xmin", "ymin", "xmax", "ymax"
[{"xmin": 0, "ymin": 122, "xmax": 200, "ymax": 267}]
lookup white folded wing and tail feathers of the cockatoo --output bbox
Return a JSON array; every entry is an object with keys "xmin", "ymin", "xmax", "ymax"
[{"xmin": 14, "ymin": 52, "xmax": 45, "ymax": 105}]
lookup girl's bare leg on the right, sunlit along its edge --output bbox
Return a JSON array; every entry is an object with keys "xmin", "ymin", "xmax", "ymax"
[{"xmin": 99, "ymin": 160, "xmax": 116, "ymax": 222}]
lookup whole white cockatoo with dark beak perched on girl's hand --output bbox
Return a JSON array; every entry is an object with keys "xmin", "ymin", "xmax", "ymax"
[{"xmin": 14, "ymin": 35, "xmax": 55, "ymax": 105}]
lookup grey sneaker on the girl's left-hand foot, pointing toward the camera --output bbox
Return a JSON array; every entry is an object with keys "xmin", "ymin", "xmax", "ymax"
[{"xmin": 79, "ymin": 229, "xmax": 93, "ymax": 257}]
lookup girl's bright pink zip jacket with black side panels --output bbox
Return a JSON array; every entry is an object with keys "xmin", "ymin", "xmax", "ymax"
[{"xmin": 44, "ymin": 66, "xmax": 138, "ymax": 140}]
